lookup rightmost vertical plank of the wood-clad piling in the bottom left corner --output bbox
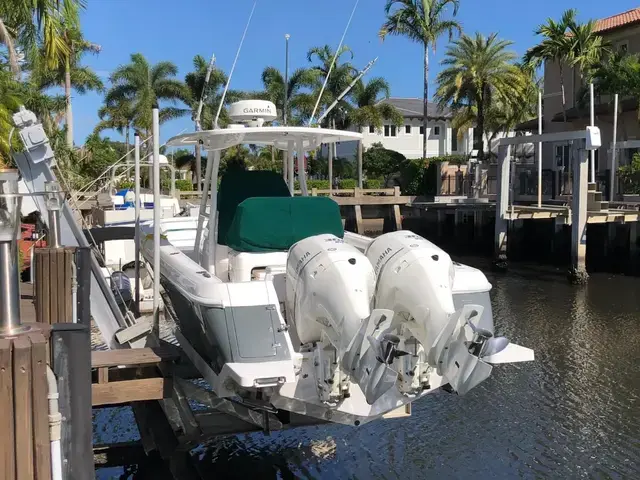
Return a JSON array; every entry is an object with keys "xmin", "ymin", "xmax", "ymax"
[{"xmin": 29, "ymin": 333, "xmax": 51, "ymax": 480}]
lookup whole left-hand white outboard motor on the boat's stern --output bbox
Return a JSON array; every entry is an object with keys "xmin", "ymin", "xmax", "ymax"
[{"xmin": 286, "ymin": 234, "xmax": 375, "ymax": 404}]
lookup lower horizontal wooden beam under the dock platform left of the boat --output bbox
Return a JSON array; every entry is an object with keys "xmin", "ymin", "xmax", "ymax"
[{"xmin": 91, "ymin": 377, "xmax": 172, "ymax": 407}]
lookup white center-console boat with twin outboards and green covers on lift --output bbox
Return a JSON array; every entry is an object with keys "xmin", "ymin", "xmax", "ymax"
[{"xmin": 142, "ymin": 101, "xmax": 533, "ymax": 425}]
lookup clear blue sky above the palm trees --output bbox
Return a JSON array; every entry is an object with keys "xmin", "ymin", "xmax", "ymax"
[{"xmin": 73, "ymin": 0, "xmax": 640, "ymax": 144}]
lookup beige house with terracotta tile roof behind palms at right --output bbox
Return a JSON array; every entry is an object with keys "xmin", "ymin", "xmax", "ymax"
[{"xmin": 518, "ymin": 8, "xmax": 640, "ymax": 196}]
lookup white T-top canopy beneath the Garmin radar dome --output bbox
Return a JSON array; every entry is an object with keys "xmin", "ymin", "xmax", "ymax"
[{"xmin": 167, "ymin": 127, "xmax": 362, "ymax": 150}]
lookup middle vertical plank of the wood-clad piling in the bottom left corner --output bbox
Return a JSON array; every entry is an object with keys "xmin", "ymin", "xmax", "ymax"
[{"xmin": 13, "ymin": 336, "xmax": 34, "ymax": 480}]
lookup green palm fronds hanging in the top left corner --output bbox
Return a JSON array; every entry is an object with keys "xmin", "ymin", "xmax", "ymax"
[{"xmin": 0, "ymin": 0, "xmax": 86, "ymax": 79}]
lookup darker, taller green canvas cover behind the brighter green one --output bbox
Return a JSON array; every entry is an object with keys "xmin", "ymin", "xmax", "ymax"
[{"xmin": 218, "ymin": 169, "xmax": 291, "ymax": 245}]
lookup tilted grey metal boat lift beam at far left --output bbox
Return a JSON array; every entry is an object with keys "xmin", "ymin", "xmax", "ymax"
[{"xmin": 13, "ymin": 107, "xmax": 144, "ymax": 348}]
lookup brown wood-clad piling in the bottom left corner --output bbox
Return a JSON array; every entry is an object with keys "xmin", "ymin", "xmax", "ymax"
[{"xmin": 0, "ymin": 330, "xmax": 51, "ymax": 480}]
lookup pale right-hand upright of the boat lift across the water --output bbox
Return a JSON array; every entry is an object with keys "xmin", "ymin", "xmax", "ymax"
[{"xmin": 569, "ymin": 140, "xmax": 589, "ymax": 284}]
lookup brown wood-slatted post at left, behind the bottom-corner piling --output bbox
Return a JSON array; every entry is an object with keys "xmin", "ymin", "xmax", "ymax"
[{"xmin": 34, "ymin": 248, "xmax": 75, "ymax": 325}]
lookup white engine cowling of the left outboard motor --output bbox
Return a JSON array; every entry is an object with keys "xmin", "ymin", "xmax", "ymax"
[{"xmin": 286, "ymin": 234, "xmax": 375, "ymax": 350}]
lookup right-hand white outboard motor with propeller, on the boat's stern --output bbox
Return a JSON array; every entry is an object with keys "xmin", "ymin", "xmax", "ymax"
[{"xmin": 366, "ymin": 231, "xmax": 533, "ymax": 395}]
